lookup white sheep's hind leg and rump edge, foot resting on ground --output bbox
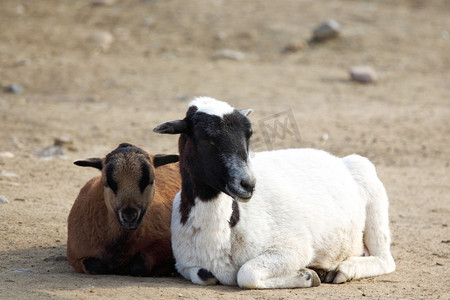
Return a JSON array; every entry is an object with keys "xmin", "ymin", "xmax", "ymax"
[{"xmin": 333, "ymin": 155, "xmax": 395, "ymax": 283}]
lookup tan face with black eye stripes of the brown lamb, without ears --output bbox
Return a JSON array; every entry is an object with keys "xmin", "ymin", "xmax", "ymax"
[{"xmin": 102, "ymin": 150, "xmax": 155, "ymax": 230}]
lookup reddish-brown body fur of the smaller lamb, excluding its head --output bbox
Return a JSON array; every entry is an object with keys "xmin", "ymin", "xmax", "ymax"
[{"xmin": 67, "ymin": 150, "xmax": 180, "ymax": 276}]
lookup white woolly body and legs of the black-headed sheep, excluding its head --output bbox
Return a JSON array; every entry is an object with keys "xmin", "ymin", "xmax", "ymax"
[{"xmin": 171, "ymin": 149, "xmax": 395, "ymax": 288}]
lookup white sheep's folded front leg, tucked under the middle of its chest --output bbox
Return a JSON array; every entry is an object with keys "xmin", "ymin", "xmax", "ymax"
[{"xmin": 237, "ymin": 252, "xmax": 320, "ymax": 289}]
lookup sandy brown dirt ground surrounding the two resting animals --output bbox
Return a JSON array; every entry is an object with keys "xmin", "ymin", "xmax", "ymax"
[{"xmin": 0, "ymin": 0, "xmax": 450, "ymax": 299}]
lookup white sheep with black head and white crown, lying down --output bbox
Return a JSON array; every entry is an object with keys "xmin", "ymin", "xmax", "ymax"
[{"xmin": 154, "ymin": 97, "xmax": 395, "ymax": 289}]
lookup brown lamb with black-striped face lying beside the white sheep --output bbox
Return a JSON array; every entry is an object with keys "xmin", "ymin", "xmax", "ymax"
[{"xmin": 67, "ymin": 143, "xmax": 180, "ymax": 276}]
